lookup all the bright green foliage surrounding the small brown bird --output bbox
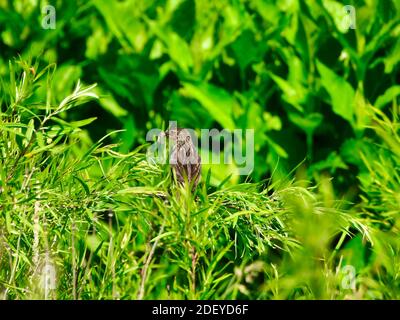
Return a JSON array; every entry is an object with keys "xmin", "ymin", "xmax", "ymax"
[{"xmin": 0, "ymin": 0, "xmax": 400, "ymax": 299}]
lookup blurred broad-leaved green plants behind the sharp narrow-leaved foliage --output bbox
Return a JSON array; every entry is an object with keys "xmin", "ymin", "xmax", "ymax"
[{"xmin": 0, "ymin": 0, "xmax": 400, "ymax": 196}]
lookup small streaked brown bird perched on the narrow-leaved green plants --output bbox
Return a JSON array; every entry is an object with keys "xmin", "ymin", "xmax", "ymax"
[{"xmin": 165, "ymin": 128, "xmax": 201, "ymax": 190}]
